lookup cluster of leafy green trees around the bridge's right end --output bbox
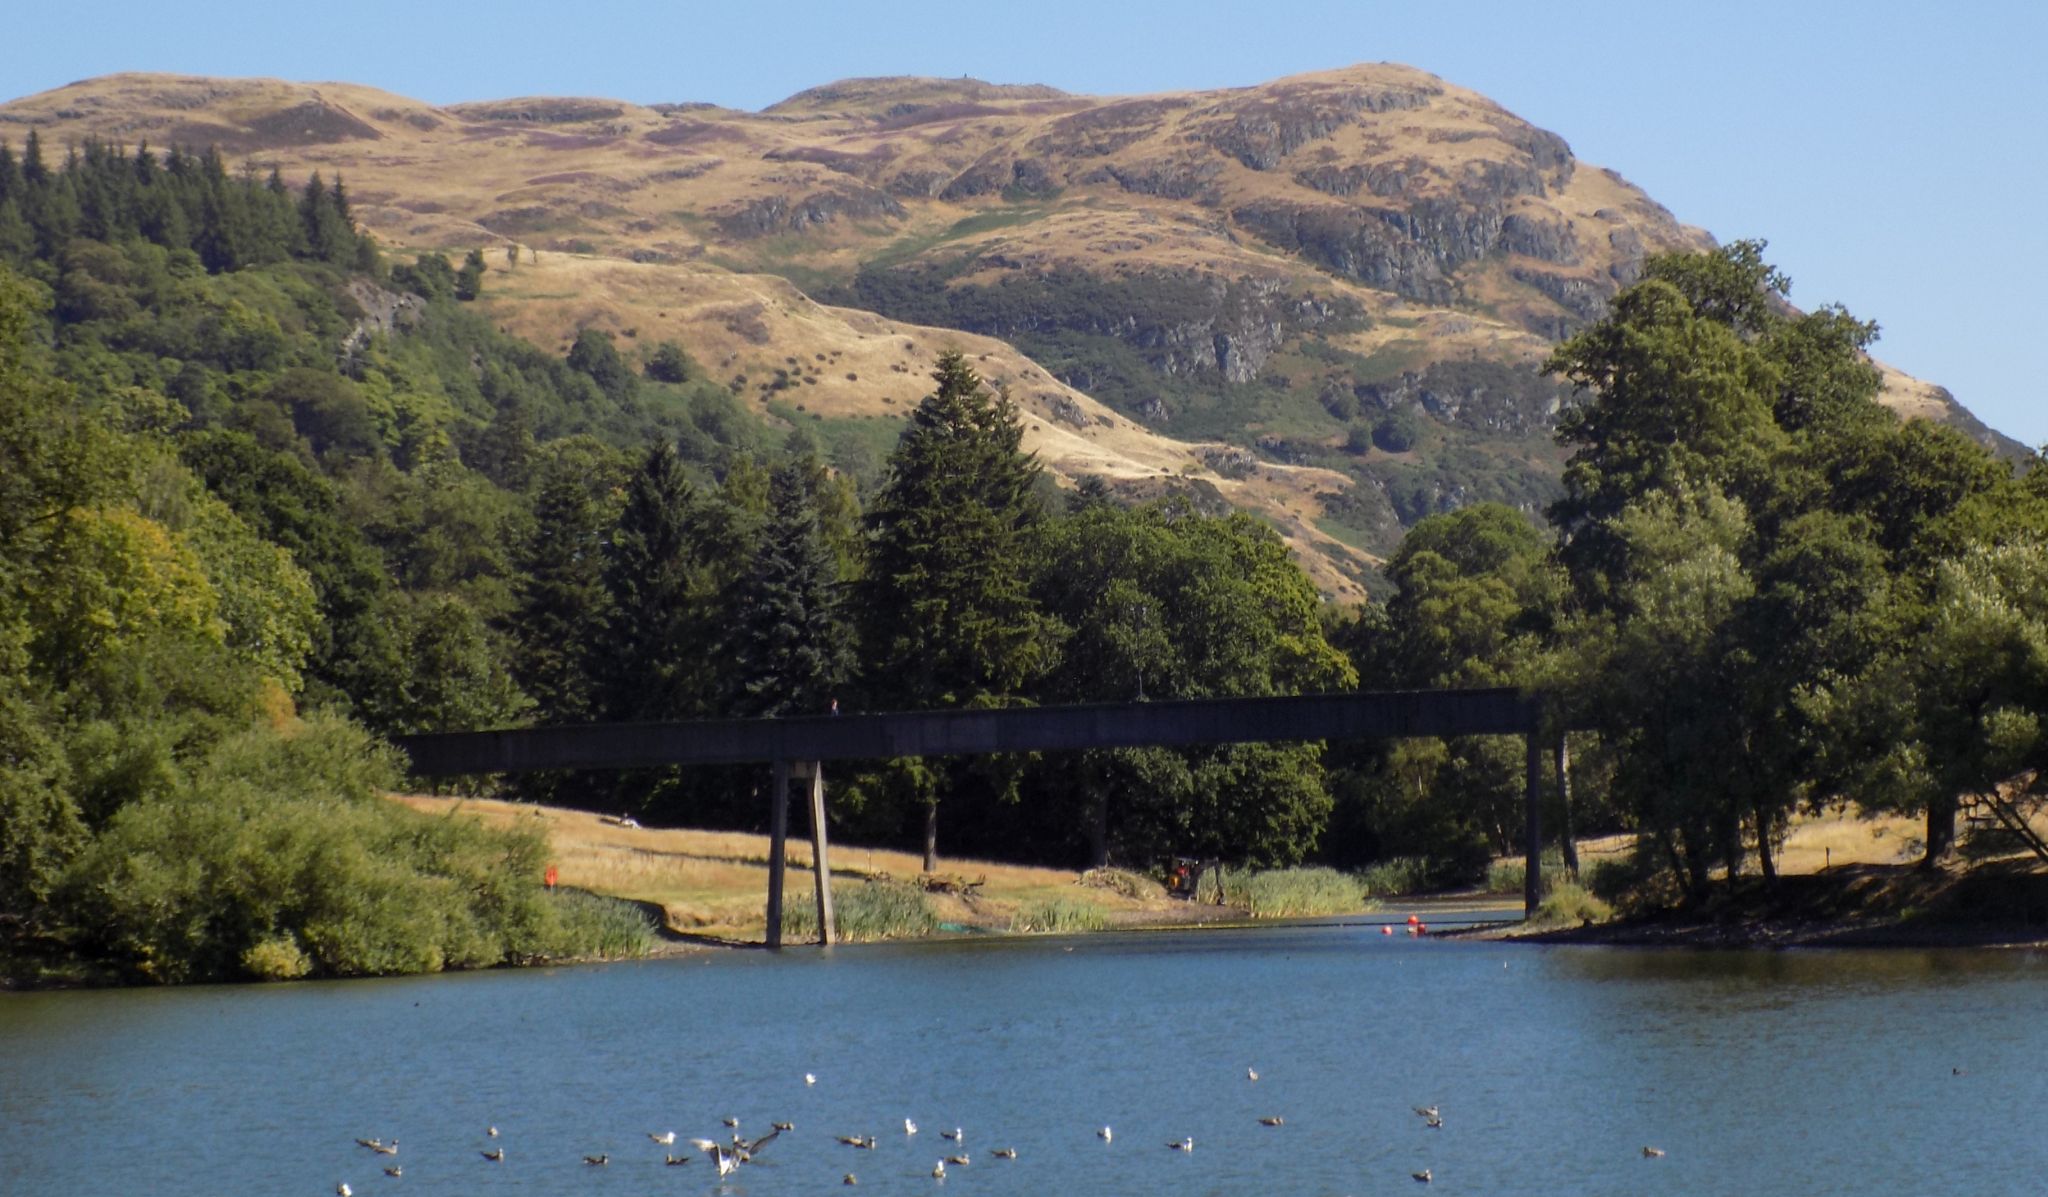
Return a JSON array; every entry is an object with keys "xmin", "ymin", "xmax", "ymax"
[{"xmin": 1339, "ymin": 242, "xmax": 2048, "ymax": 894}]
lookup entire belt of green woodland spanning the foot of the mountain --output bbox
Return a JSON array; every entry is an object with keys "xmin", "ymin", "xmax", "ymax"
[{"xmin": 0, "ymin": 141, "xmax": 2048, "ymax": 980}]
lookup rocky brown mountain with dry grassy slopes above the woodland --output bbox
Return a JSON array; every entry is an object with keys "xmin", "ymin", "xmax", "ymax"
[{"xmin": 0, "ymin": 66, "xmax": 2009, "ymax": 594}]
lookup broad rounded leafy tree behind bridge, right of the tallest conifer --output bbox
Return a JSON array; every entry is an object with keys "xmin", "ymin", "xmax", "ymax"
[{"xmin": 1034, "ymin": 498, "xmax": 1356, "ymax": 867}]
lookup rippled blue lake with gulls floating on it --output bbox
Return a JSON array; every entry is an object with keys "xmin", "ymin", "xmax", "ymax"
[{"xmin": 0, "ymin": 912, "xmax": 2048, "ymax": 1197}]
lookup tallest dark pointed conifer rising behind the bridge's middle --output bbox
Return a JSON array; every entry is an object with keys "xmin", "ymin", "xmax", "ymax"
[{"xmin": 858, "ymin": 353, "xmax": 1059, "ymax": 869}]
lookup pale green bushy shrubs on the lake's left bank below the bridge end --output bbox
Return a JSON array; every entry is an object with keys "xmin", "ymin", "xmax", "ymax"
[{"xmin": 59, "ymin": 717, "xmax": 651, "ymax": 982}]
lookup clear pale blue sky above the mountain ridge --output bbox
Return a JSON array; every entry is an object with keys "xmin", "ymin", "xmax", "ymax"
[{"xmin": 0, "ymin": 0, "xmax": 2048, "ymax": 445}]
